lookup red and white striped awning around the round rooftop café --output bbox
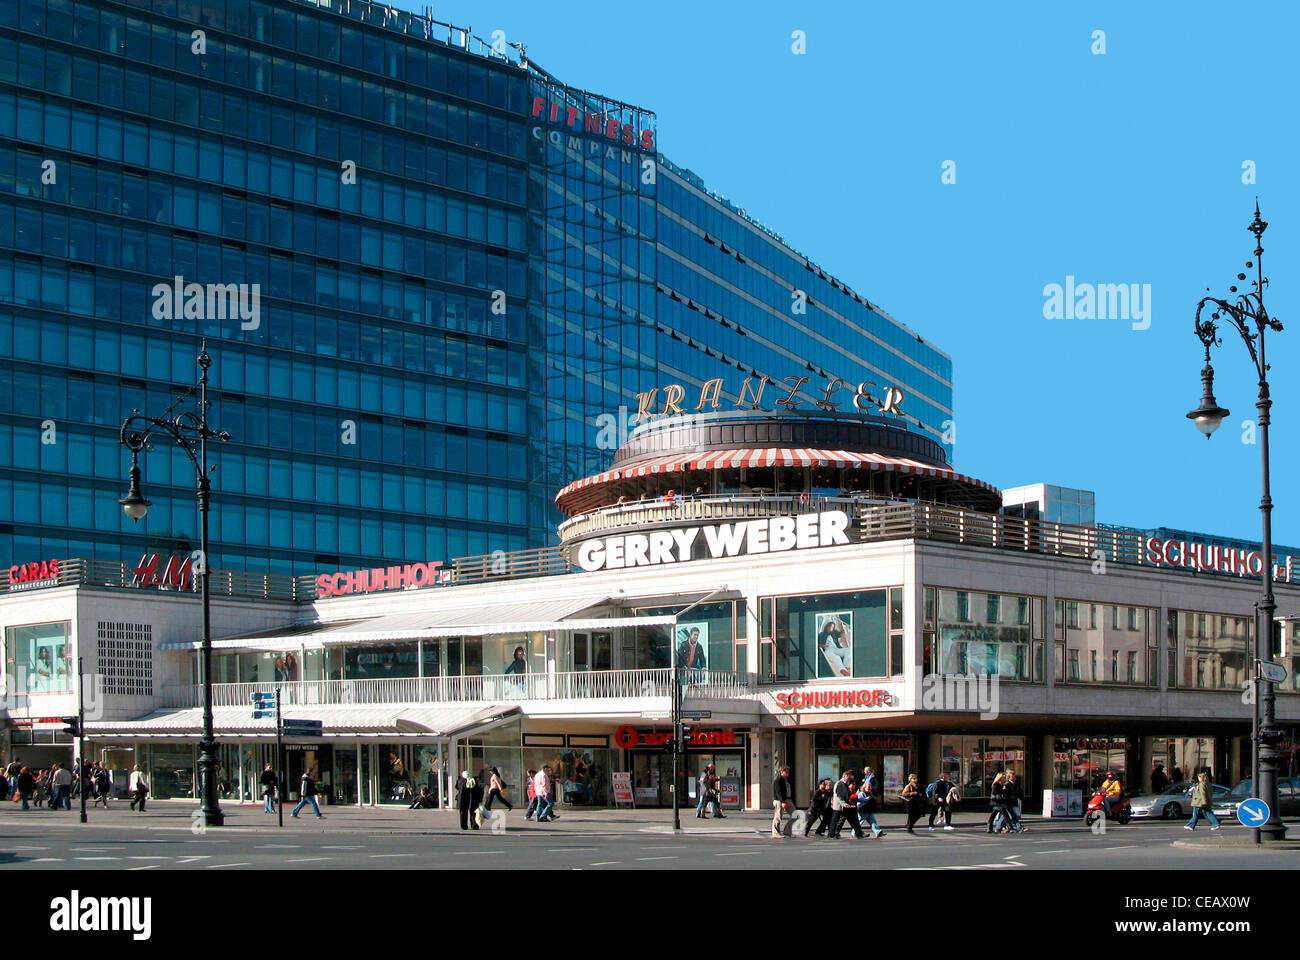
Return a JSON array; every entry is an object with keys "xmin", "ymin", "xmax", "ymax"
[{"xmin": 555, "ymin": 446, "xmax": 1001, "ymax": 502}]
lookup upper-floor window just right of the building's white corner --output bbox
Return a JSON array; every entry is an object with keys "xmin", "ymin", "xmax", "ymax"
[{"xmin": 926, "ymin": 587, "xmax": 1045, "ymax": 680}]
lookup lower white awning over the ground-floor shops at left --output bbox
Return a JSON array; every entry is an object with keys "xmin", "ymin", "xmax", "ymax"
[{"xmin": 87, "ymin": 704, "xmax": 523, "ymax": 740}]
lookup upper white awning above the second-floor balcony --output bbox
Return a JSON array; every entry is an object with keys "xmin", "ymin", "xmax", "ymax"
[{"xmin": 159, "ymin": 594, "xmax": 672, "ymax": 650}]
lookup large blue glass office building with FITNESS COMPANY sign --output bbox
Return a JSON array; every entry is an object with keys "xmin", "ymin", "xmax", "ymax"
[{"xmin": 0, "ymin": 0, "xmax": 952, "ymax": 574}]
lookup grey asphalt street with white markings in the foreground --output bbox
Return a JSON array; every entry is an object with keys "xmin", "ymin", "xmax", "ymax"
[{"xmin": 0, "ymin": 801, "xmax": 1300, "ymax": 870}]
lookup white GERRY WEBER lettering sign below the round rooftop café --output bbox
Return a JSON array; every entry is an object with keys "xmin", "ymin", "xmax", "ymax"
[{"xmin": 577, "ymin": 510, "xmax": 849, "ymax": 571}]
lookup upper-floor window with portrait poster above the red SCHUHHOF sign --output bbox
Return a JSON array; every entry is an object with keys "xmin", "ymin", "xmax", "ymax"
[{"xmin": 759, "ymin": 589, "xmax": 889, "ymax": 683}]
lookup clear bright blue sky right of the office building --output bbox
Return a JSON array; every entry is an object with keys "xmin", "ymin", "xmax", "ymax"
[{"xmin": 421, "ymin": 0, "xmax": 1300, "ymax": 544}]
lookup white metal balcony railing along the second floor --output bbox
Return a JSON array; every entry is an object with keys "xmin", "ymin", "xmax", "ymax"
[{"xmin": 160, "ymin": 667, "xmax": 751, "ymax": 708}]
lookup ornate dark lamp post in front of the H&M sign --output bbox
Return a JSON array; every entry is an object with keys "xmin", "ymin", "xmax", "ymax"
[{"xmin": 118, "ymin": 341, "xmax": 230, "ymax": 826}]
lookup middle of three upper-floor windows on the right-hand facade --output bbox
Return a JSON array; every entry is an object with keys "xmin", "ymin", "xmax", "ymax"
[{"xmin": 1056, "ymin": 600, "xmax": 1160, "ymax": 687}]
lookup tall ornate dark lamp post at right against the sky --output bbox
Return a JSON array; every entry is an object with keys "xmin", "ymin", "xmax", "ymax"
[{"xmin": 1187, "ymin": 202, "xmax": 1287, "ymax": 840}]
